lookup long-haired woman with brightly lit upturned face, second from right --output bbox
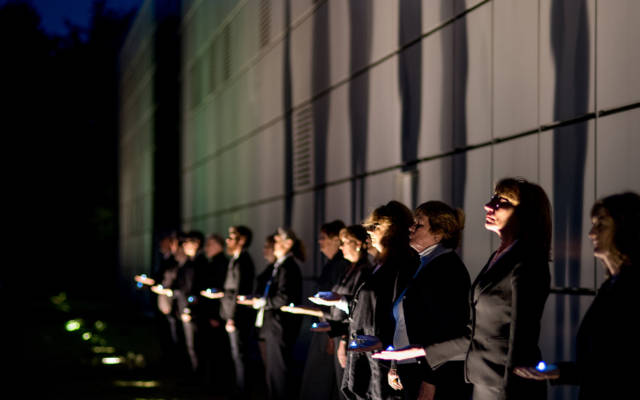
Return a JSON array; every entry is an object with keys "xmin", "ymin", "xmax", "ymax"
[{"xmin": 374, "ymin": 178, "xmax": 551, "ymax": 400}]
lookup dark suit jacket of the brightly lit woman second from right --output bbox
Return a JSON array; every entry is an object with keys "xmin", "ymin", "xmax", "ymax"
[{"xmin": 426, "ymin": 242, "xmax": 550, "ymax": 398}]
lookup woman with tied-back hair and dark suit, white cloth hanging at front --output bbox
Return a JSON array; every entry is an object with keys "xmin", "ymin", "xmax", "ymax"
[{"xmin": 253, "ymin": 228, "xmax": 305, "ymax": 400}]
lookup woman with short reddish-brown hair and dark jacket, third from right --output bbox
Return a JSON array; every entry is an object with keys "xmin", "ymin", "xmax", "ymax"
[{"xmin": 388, "ymin": 201, "xmax": 471, "ymax": 400}]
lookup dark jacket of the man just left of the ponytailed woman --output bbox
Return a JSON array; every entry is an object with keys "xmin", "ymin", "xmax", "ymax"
[{"xmin": 220, "ymin": 250, "xmax": 255, "ymax": 327}]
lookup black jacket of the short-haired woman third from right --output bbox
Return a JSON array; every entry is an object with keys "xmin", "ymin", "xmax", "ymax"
[{"xmin": 402, "ymin": 251, "xmax": 471, "ymax": 386}]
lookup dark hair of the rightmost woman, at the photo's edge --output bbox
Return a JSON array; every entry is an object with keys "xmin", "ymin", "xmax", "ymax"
[{"xmin": 591, "ymin": 192, "xmax": 640, "ymax": 265}]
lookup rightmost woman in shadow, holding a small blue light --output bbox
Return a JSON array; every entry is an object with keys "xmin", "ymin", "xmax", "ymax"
[{"xmin": 515, "ymin": 192, "xmax": 640, "ymax": 400}]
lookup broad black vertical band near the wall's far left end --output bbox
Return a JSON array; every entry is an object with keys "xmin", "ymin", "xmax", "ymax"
[{"xmin": 152, "ymin": 2, "xmax": 182, "ymax": 272}]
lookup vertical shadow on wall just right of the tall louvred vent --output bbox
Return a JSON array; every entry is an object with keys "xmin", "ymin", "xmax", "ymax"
[{"xmin": 311, "ymin": 3, "xmax": 330, "ymax": 276}]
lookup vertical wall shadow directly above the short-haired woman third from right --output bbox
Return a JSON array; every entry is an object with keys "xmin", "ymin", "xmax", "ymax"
[{"xmin": 441, "ymin": 0, "xmax": 469, "ymax": 209}]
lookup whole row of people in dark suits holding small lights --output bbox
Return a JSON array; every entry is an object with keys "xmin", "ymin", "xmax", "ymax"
[{"xmin": 134, "ymin": 178, "xmax": 640, "ymax": 400}]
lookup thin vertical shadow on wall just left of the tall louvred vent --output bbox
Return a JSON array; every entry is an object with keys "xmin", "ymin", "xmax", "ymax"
[{"xmin": 282, "ymin": 0, "xmax": 293, "ymax": 226}]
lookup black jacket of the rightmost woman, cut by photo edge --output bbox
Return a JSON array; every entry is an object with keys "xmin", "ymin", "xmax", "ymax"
[{"xmin": 557, "ymin": 265, "xmax": 640, "ymax": 400}]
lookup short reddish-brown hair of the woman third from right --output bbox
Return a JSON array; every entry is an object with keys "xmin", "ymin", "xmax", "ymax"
[{"xmin": 415, "ymin": 200, "xmax": 464, "ymax": 249}]
